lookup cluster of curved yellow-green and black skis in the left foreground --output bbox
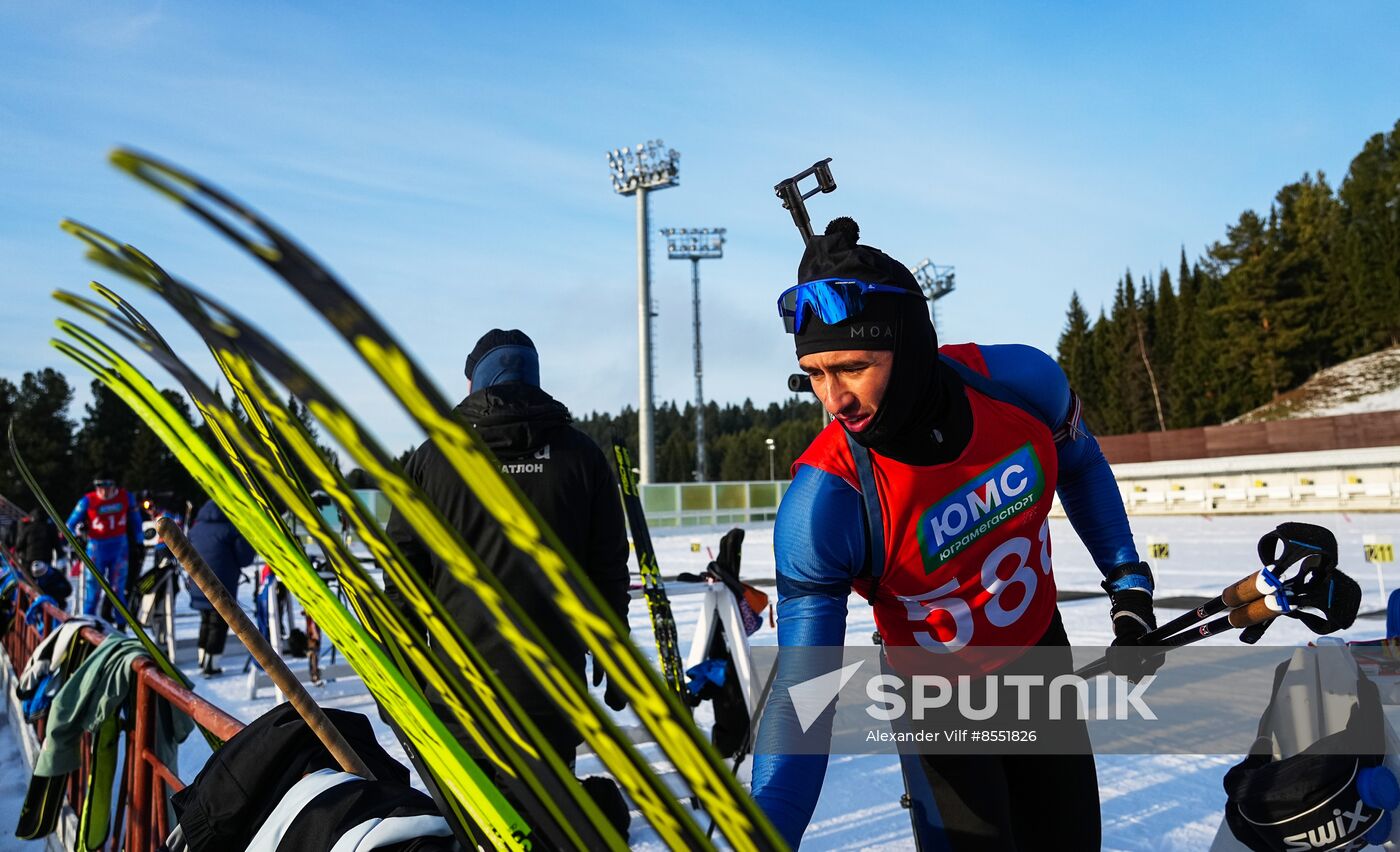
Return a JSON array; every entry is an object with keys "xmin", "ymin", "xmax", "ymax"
[{"xmin": 19, "ymin": 150, "xmax": 783, "ymax": 851}]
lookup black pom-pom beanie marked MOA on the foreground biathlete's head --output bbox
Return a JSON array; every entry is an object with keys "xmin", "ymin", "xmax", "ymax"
[{"xmin": 794, "ymin": 215, "xmax": 925, "ymax": 358}]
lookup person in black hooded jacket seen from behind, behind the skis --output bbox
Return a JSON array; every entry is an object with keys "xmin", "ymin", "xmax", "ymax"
[{"xmin": 388, "ymin": 329, "xmax": 630, "ymax": 828}]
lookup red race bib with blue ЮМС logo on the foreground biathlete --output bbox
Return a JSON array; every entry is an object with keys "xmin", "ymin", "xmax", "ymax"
[{"xmin": 797, "ymin": 344, "xmax": 1058, "ymax": 653}]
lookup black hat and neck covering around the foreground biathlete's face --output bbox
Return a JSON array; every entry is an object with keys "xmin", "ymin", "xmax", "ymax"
[{"xmin": 794, "ymin": 217, "xmax": 972, "ymax": 464}]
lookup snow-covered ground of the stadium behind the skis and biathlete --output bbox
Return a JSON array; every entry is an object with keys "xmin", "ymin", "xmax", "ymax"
[{"xmin": 8, "ymin": 513, "xmax": 1400, "ymax": 852}]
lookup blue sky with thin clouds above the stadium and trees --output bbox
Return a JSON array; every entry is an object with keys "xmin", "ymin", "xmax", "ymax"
[{"xmin": 0, "ymin": 0, "xmax": 1400, "ymax": 450}]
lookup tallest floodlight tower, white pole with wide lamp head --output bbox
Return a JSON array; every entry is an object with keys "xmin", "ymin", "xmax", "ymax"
[{"xmin": 608, "ymin": 139, "xmax": 680, "ymax": 483}]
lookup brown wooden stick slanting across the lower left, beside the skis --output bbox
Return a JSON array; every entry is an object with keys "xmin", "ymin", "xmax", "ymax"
[{"xmin": 155, "ymin": 518, "xmax": 374, "ymax": 779}]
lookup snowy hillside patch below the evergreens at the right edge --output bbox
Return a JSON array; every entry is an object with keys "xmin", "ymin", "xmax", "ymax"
[{"xmin": 1231, "ymin": 347, "xmax": 1400, "ymax": 423}]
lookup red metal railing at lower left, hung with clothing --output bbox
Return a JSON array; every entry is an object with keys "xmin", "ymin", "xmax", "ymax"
[{"xmin": 0, "ymin": 573, "xmax": 244, "ymax": 852}]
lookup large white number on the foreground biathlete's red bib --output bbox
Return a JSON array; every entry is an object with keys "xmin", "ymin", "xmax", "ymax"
[{"xmin": 899, "ymin": 519, "xmax": 1050, "ymax": 653}]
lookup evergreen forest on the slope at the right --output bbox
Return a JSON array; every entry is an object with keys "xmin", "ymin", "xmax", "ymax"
[{"xmin": 1058, "ymin": 122, "xmax": 1400, "ymax": 435}]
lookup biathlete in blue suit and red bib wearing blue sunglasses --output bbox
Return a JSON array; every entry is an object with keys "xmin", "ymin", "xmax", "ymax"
[{"xmin": 753, "ymin": 217, "xmax": 1161, "ymax": 852}]
